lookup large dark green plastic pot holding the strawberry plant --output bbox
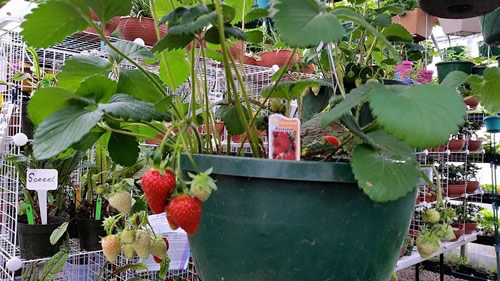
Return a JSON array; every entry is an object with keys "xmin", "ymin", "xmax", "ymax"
[{"xmin": 181, "ymin": 155, "xmax": 416, "ymax": 281}]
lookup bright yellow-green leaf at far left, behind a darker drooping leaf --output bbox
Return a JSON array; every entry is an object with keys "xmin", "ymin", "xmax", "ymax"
[{"xmin": 28, "ymin": 88, "xmax": 89, "ymax": 126}]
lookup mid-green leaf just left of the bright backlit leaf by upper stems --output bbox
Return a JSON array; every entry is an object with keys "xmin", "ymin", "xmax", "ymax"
[{"xmin": 116, "ymin": 69, "xmax": 164, "ymax": 102}]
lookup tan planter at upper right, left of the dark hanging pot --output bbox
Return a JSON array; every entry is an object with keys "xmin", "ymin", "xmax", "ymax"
[{"xmin": 392, "ymin": 8, "xmax": 434, "ymax": 42}]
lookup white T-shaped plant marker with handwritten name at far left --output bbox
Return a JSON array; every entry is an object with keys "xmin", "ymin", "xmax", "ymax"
[{"xmin": 26, "ymin": 169, "xmax": 58, "ymax": 224}]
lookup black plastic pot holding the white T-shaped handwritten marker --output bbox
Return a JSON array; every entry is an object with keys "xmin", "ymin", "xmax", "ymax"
[{"xmin": 17, "ymin": 216, "xmax": 66, "ymax": 260}]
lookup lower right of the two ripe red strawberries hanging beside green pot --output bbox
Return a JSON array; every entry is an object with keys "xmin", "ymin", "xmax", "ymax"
[{"xmin": 167, "ymin": 195, "xmax": 201, "ymax": 234}]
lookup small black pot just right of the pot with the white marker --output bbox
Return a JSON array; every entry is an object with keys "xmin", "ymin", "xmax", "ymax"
[{"xmin": 76, "ymin": 218, "xmax": 106, "ymax": 251}]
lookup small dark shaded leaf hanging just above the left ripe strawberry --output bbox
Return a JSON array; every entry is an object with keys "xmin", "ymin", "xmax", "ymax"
[{"xmin": 108, "ymin": 132, "xmax": 140, "ymax": 167}]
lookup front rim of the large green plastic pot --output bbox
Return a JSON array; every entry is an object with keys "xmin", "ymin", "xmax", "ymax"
[{"xmin": 181, "ymin": 154, "xmax": 356, "ymax": 183}]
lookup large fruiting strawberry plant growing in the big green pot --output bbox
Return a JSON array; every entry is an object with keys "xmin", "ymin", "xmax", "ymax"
[{"xmin": 17, "ymin": 0, "xmax": 499, "ymax": 277}]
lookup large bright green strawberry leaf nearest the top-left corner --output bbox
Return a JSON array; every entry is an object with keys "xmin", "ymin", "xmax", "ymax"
[{"xmin": 21, "ymin": 0, "xmax": 90, "ymax": 48}]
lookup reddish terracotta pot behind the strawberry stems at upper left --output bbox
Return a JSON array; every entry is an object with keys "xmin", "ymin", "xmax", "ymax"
[{"xmin": 118, "ymin": 17, "xmax": 167, "ymax": 46}]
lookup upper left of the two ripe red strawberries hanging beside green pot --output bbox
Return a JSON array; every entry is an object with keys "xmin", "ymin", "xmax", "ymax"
[{"xmin": 141, "ymin": 168, "xmax": 175, "ymax": 214}]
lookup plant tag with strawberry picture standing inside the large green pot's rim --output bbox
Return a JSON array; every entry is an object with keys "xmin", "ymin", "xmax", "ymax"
[{"xmin": 269, "ymin": 114, "xmax": 300, "ymax": 160}]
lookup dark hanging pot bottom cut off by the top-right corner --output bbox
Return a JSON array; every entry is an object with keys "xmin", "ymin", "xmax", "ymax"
[{"xmin": 418, "ymin": 0, "xmax": 500, "ymax": 19}]
